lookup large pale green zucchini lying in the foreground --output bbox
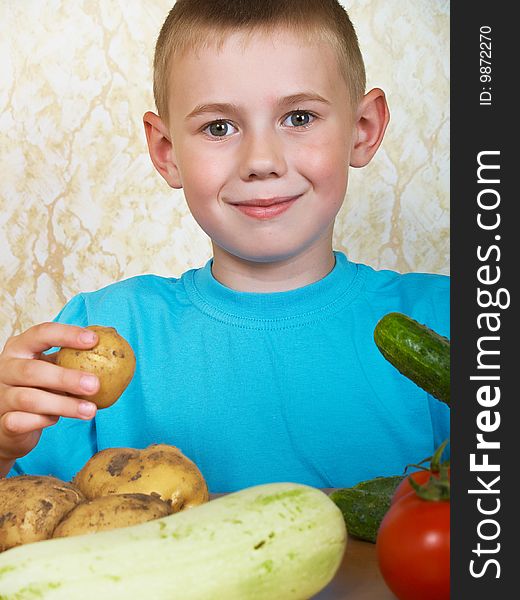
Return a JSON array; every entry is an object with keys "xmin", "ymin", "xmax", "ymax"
[{"xmin": 0, "ymin": 483, "xmax": 346, "ymax": 600}]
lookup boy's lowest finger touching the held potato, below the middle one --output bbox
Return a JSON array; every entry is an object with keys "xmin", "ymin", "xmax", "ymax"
[{"xmin": 4, "ymin": 387, "xmax": 96, "ymax": 420}]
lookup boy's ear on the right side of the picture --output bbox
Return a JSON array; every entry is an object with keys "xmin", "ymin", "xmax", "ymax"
[{"xmin": 350, "ymin": 88, "xmax": 390, "ymax": 167}]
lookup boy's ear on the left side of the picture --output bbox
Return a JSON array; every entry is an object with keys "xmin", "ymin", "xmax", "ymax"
[{"xmin": 143, "ymin": 111, "xmax": 182, "ymax": 189}]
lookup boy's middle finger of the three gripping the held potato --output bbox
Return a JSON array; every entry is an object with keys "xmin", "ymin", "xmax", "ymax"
[{"xmin": 2, "ymin": 358, "xmax": 99, "ymax": 396}]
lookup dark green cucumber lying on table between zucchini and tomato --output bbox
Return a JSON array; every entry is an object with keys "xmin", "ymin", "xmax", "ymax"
[{"xmin": 329, "ymin": 475, "xmax": 403, "ymax": 543}]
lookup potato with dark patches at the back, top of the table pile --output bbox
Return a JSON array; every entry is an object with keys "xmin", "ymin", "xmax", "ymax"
[{"xmin": 73, "ymin": 444, "xmax": 209, "ymax": 512}]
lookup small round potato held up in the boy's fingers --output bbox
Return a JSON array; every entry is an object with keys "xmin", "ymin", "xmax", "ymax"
[{"xmin": 56, "ymin": 325, "xmax": 135, "ymax": 408}]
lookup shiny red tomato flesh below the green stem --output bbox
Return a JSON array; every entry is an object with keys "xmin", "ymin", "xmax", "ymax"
[{"xmin": 376, "ymin": 494, "xmax": 450, "ymax": 600}]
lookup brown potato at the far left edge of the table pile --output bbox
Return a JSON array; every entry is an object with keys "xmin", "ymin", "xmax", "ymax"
[{"xmin": 0, "ymin": 475, "xmax": 85, "ymax": 551}]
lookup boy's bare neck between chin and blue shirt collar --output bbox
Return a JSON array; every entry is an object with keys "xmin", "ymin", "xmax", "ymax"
[{"xmin": 212, "ymin": 244, "xmax": 336, "ymax": 293}]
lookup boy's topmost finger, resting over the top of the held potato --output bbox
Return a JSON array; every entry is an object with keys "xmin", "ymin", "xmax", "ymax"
[{"xmin": 4, "ymin": 323, "xmax": 97, "ymax": 358}]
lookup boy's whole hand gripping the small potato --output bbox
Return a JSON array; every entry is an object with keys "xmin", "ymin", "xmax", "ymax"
[{"xmin": 0, "ymin": 323, "xmax": 99, "ymax": 475}]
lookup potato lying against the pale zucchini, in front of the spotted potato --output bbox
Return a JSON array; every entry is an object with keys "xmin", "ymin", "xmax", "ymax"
[{"xmin": 52, "ymin": 494, "xmax": 171, "ymax": 538}]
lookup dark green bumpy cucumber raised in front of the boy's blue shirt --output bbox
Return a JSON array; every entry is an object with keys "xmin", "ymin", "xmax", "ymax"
[{"xmin": 374, "ymin": 312, "xmax": 450, "ymax": 405}]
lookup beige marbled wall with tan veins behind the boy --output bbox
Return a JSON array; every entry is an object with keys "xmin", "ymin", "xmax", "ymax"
[{"xmin": 0, "ymin": 0, "xmax": 449, "ymax": 347}]
